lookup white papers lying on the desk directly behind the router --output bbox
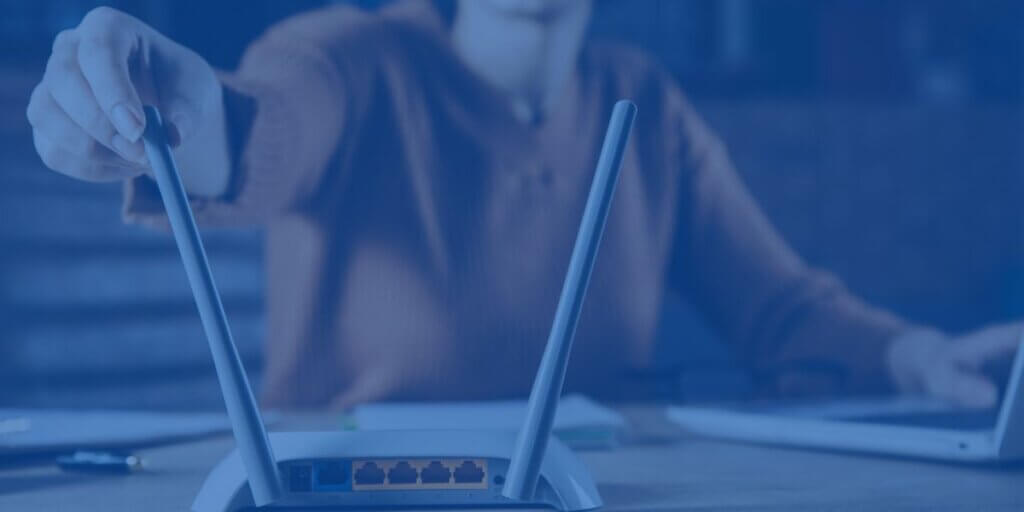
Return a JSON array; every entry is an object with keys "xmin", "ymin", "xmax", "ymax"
[{"xmin": 353, "ymin": 394, "xmax": 627, "ymax": 447}]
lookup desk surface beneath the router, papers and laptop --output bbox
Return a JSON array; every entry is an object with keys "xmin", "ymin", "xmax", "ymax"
[{"xmin": 0, "ymin": 407, "xmax": 1024, "ymax": 512}]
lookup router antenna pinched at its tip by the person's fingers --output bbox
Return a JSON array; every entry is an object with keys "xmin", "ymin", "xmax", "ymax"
[{"xmin": 142, "ymin": 106, "xmax": 282, "ymax": 507}]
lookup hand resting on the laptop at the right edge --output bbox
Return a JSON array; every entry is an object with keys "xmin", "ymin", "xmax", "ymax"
[{"xmin": 888, "ymin": 324, "xmax": 1024, "ymax": 409}]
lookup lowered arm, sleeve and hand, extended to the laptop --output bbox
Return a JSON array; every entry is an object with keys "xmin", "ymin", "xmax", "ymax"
[{"xmin": 673, "ymin": 97, "xmax": 1022, "ymax": 408}]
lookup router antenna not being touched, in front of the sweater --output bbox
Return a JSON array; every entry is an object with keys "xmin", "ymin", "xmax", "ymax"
[{"xmin": 502, "ymin": 99, "xmax": 637, "ymax": 502}]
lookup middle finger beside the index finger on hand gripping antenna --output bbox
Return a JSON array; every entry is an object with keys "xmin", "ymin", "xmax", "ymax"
[{"xmin": 43, "ymin": 31, "xmax": 144, "ymax": 162}]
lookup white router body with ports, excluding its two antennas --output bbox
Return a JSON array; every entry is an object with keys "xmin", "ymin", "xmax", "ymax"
[{"xmin": 193, "ymin": 430, "xmax": 601, "ymax": 512}]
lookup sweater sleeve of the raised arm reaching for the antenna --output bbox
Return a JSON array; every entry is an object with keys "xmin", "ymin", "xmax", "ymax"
[{"xmin": 124, "ymin": 7, "xmax": 374, "ymax": 225}]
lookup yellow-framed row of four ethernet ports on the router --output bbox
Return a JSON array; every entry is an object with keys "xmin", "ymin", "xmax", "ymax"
[{"xmin": 352, "ymin": 459, "xmax": 487, "ymax": 490}]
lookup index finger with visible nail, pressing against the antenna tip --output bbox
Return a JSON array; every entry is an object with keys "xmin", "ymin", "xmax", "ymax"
[{"xmin": 78, "ymin": 8, "xmax": 145, "ymax": 142}]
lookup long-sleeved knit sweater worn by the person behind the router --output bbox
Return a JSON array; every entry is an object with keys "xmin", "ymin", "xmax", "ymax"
[{"xmin": 125, "ymin": 2, "xmax": 907, "ymax": 408}]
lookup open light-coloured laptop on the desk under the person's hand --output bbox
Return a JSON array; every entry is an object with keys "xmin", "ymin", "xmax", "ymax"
[{"xmin": 668, "ymin": 337, "xmax": 1024, "ymax": 463}]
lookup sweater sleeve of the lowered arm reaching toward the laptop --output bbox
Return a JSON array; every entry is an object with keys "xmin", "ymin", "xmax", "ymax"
[{"xmin": 673, "ymin": 96, "xmax": 910, "ymax": 396}]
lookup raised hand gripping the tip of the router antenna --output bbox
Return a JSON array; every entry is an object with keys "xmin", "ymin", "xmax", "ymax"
[{"xmin": 27, "ymin": 7, "xmax": 228, "ymax": 195}]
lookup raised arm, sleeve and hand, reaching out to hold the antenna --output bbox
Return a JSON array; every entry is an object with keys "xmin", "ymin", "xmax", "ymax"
[{"xmin": 27, "ymin": 7, "xmax": 375, "ymax": 224}]
